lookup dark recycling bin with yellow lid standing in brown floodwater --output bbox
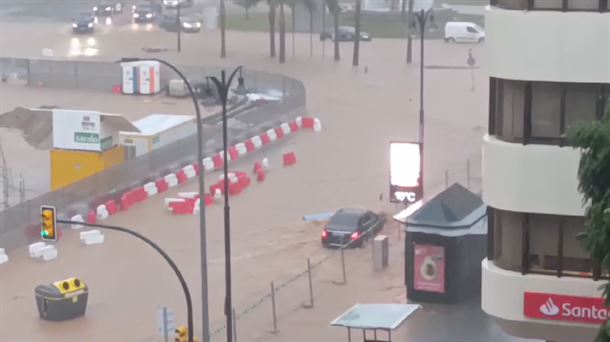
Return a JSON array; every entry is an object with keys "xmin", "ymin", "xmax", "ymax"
[{"xmin": 34, "ymin": 278, "xmax": 89, "ymax": 321}]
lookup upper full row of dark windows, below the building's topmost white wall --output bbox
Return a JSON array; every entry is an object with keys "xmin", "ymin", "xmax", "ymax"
[{"xmin": 489, "ymin": 78, "xmax": 610, "ymax": 145}]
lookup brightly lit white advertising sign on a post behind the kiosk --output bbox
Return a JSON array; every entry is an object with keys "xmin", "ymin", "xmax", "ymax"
[{"xmin": 390, "ymin": 142, "xmax": 424, "ymax": 205}]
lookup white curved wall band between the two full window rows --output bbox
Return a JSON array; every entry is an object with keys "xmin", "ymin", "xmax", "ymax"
[{"xmin": 482, "ymin": 135, "xmax": 584, "ymax": 216}]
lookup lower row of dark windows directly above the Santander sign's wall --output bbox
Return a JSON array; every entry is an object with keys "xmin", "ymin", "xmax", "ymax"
[{"xmin": 488, "ymin": 208, "xmax": 608, "ymax": 278}]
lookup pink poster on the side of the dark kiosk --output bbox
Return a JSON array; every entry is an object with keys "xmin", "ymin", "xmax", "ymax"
[{"xmin": 413, "ymin": 244, "xmax": 445, "ymax": 293}]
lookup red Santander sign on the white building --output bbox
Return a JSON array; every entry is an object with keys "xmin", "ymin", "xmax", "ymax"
[{"xmin": 523, "ymin": 292, "xmax": 610, "ymax": 325}]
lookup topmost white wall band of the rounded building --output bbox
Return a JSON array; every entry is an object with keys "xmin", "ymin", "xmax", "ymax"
[{"xmin": 485, "ymin": 7, "xmax": 610, "ymax": 83}]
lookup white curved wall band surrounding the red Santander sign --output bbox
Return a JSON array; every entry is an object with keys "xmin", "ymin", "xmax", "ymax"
[{"xmin": 481, "ymin": 259, "xmax": 604, "ymax": 341}]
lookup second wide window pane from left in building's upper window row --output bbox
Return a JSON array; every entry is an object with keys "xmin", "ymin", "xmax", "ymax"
[{"xmin": 532, "ymin": 82, "xmax": 561, "ymax": 138}]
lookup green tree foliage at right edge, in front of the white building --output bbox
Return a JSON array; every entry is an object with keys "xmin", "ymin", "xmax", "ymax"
[{"xmin": 568, "ymin": 110, "xmax": 610, "ymax": 342}]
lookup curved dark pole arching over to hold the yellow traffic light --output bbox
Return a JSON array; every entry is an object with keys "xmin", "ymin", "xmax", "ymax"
[{"xmin": 57, "ymin": 220, "xmax": 193, "ymax": 342}]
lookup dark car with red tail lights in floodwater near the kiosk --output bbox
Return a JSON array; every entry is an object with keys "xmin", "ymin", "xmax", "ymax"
[{"xmin": 321, "ymin": 209, "xmax": 386, "ymax": 248}]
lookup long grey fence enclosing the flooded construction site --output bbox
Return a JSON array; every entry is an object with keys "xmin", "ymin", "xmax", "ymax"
[{"xmin": 0, "ymin": 58, "xmax": 305, "ymax": 250}]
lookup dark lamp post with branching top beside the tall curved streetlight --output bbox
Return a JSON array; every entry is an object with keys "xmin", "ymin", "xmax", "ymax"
[{"xmin": 206, "ymin": 65, "xmax": 244, "ymax": 342}]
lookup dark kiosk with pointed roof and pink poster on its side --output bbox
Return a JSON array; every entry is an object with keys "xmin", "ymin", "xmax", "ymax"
[{"xmin": 405, "ymin": 183, "xmax": 487, "ymax": 304}]
